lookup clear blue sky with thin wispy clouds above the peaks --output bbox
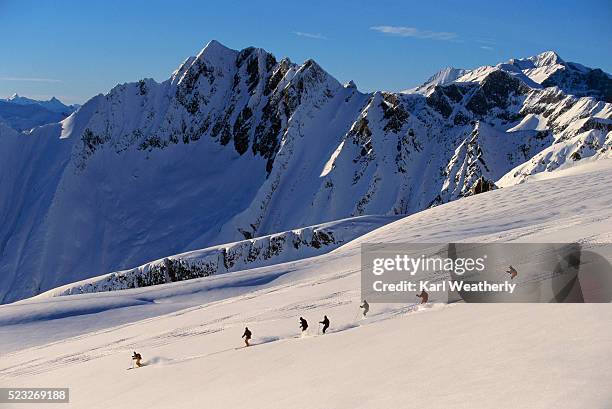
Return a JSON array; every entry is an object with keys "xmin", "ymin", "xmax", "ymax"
[{"xmin": 0, "ymin": 0, "xmax": 612, "ymax": 103}]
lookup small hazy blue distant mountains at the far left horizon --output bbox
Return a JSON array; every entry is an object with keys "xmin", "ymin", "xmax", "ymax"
[{"xmin": 0, "ymin": 94, "xmax": 80, "ymax": 131}]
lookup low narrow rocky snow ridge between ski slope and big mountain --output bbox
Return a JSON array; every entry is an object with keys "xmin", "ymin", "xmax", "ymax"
[{"xmin": 37, "ymin": 216, "xmax": 398, "ymax": 298}]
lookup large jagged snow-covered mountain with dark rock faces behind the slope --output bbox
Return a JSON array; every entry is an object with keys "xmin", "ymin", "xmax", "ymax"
[{"xmin": 0, "ymin": 41, "xmax": 612, "ymax": 302}]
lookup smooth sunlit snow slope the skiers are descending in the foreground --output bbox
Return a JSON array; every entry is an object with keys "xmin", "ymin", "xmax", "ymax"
[{"xmin": 0, "ymin": 160, "xmax": 612, "ymax": 409}]
